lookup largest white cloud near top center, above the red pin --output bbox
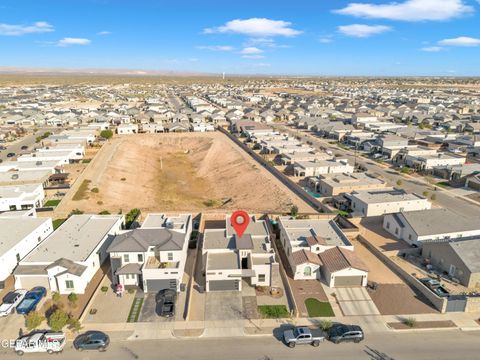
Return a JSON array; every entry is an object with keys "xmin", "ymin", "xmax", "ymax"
[{"xmin": 204, "ymin": 18, "xmax": 302, "ymax": 37}]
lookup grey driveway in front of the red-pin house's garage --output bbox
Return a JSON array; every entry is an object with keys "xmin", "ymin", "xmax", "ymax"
[{"xmin": 205, "ymin": 291, "xmax": 243, "ymax": 321}]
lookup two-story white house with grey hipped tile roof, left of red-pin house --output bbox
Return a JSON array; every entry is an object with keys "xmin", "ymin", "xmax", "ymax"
[{"xmin": 107, "ymin": 214, "xmax": 192, "ymax": 292}]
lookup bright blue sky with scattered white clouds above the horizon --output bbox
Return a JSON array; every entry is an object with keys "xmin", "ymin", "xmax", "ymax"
[{"xmin": 0, "ymin": 0, "xmax": 480, "ymax": 76}]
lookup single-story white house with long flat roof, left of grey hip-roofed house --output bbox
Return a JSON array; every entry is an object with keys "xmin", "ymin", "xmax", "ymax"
[{"xmin": 14, "ymin": 215, "xmax": 124, "ymax": 294}]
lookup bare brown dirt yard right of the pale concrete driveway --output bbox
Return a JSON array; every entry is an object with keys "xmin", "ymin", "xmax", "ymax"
[{"xmin": 368, "ymin": 284, "xmax": 438, "ymax": 315}]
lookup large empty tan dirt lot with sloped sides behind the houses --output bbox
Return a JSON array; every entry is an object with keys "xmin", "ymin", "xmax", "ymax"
[{"xmin": 57, "ymin": 132, "xmax": 312, "ymax": 215}]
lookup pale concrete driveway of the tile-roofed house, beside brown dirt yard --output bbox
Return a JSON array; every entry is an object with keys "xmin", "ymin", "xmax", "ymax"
[{"xmin": 335, "ymin": 287, "xmax": 380, "ymax": 316}]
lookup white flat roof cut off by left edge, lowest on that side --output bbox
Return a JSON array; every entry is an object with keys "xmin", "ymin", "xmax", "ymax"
[{"xmin": 0, "ymin": 214, "xmax": 51, "ymax": 255}]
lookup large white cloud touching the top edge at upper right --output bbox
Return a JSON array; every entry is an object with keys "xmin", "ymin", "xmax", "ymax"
[{"xmin": 334, "ymin": 0, "xmax": 474, "ymax": 21}]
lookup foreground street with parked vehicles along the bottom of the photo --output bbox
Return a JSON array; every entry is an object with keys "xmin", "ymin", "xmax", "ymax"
[{"xmin": 0, "ymin": 330, "xmax": 480, "ymax": 360}]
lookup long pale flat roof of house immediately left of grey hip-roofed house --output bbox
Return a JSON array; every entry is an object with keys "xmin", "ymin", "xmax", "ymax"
[{"xmin": 22, "ymin": 215, "xmax": 123, "ymax": 264}]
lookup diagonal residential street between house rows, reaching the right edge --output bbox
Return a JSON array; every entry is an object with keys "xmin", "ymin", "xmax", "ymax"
[{"xmin": 273, "ymin": 125, "xmax": 480, "ymax": 217}]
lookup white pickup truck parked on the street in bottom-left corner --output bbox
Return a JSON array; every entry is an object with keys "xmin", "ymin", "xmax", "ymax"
[{"xmin": 15, "ymin": 331, "xmax": 66, "ymax": 356}]
